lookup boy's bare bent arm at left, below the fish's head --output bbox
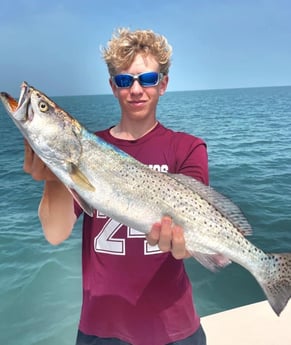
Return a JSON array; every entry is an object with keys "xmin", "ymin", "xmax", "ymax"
[{"xmin": 39, "ymin": 181, "xmax": 76, "ymax": 245}]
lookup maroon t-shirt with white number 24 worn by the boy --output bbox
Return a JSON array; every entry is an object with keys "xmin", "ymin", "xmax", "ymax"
[{"xmin": 75, "ymin": 123, "xmax": 208, "ymax": 345}]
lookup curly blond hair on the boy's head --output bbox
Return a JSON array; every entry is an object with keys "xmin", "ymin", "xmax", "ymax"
[{"xmin": 102, "ymin": 28, "xmax": 172, "ymax": 76}]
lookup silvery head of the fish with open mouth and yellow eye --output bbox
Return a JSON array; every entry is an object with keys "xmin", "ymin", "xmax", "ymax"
[{"xmin": 0, "ymin": 82, "xmax": 82, "ymax": 175}]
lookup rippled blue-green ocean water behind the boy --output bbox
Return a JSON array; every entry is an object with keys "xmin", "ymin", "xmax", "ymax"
[{"xmin": 0, "ymin": 87, "xmax": 291, "ymax": 345}]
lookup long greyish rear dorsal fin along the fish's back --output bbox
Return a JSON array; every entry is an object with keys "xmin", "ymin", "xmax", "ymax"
[{"xmin": 169, "ymin": 174, "xmax": 252, "ymax": 236}]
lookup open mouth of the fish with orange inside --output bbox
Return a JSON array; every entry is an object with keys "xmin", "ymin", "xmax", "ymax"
[{"xmin": 0, "ymin": 81, "xmax": 33, "ymax": 122}]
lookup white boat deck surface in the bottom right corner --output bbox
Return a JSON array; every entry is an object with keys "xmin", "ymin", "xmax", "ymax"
[{"xmin": 201, "ymin": 301, "xmax": 291, "ymax": 345}]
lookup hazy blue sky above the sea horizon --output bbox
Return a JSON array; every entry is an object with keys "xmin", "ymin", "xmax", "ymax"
[{"xmin": 0, "ymin": 0, "xmax": 291, "ymax": 97}]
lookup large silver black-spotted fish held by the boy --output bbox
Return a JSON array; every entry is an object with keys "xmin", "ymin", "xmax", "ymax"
[{"xmin": 0, "ymin": 82, "xmax": 291, "ymax": 316}]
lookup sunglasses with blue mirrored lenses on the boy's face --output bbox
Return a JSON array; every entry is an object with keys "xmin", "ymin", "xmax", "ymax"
[{"xmin": 111, "ymin": 72, "xmax": 163, "ymax": 88}]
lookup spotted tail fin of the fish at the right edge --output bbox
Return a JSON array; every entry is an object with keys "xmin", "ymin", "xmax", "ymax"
[{"xmin": 260, "ymin": 253, "xmax": 291, "ymax": 316}]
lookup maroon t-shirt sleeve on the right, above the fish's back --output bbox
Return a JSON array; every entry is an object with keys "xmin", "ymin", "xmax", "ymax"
[{"xmin": 176, "ymin": 134, "xmax": 209, "ymax": 185}]
